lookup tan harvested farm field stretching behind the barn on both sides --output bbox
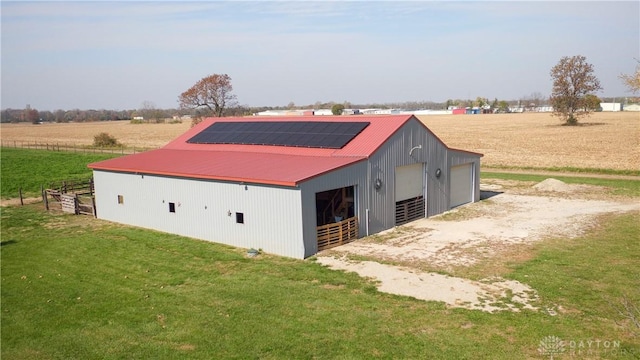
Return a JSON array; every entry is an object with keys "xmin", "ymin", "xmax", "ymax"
[{"xmin": 0, "ymin": 112, "xmax": 640, "ymax": 171}]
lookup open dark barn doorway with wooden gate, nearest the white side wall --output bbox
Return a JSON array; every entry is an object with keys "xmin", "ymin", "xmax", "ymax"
[{"xmin": 316, "ymin": 186, "xmax": 358, "ymax": 251}]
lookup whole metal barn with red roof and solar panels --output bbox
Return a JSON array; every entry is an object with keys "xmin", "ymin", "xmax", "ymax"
[{"xmin": 89, "ymin": 115, "xmax": 482, "ymax": 258}]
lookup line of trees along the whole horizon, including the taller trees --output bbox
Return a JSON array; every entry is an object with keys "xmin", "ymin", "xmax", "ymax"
[{"xmin": 0, "ymin": 55, "xmax": 640, "ymax": 125}]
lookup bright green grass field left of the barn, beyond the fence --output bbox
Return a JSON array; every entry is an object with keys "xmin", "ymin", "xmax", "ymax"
[{"xmin": 0, "ymin": 148, "xmax": 120, "ymax": 199}]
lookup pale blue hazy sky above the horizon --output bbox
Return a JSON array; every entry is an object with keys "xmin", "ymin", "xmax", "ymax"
[{"xmin": 0, "ymin": 0, "xmax": 640, "ymax": 111}]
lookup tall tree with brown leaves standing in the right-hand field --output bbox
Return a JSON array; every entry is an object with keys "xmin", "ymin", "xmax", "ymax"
[{"xmin": 549, "ymin": 55, "xmax": 602, "ymax": 125}]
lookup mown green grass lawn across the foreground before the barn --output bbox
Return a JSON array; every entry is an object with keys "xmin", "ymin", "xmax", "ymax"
[{"xmin": 1, "ymin": 205, "xmax": 640, "ymax": 359}]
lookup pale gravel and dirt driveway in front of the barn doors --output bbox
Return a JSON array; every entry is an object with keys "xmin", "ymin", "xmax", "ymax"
[{"xmin": 318, "ymin": 179, "xmax": 640, "ymax": 312}]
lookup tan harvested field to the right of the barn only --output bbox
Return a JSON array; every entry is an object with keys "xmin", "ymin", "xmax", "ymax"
[{"xmin": 420, "ymin": 112, "xmax": 640, "ymax": 170}]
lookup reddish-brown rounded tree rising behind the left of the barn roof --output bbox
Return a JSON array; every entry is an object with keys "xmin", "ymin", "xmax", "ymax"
[{"xmin": 178, "ymin": 74, "xmax": 236, "ymax": 117}]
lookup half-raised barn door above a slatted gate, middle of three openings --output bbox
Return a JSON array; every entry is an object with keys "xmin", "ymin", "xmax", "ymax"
[{"xmin": 396, "ymin": 163, "xmax": 425, "ymax": 225}]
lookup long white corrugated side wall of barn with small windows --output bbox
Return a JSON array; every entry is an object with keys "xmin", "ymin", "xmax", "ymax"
[{"xmin": 94, "ymin": 171, "xmax": 304, "ymax": 258}]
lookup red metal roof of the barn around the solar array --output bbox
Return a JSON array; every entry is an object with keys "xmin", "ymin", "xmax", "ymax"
[{"xmin": 89, "ymin": 115, "xmax": 413, "ymax": 186}]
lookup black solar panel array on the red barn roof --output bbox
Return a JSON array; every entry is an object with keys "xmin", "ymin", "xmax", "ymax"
[{"xmin": 187, "ymin": 121, "xmax": 369, "ymax": 149}]
